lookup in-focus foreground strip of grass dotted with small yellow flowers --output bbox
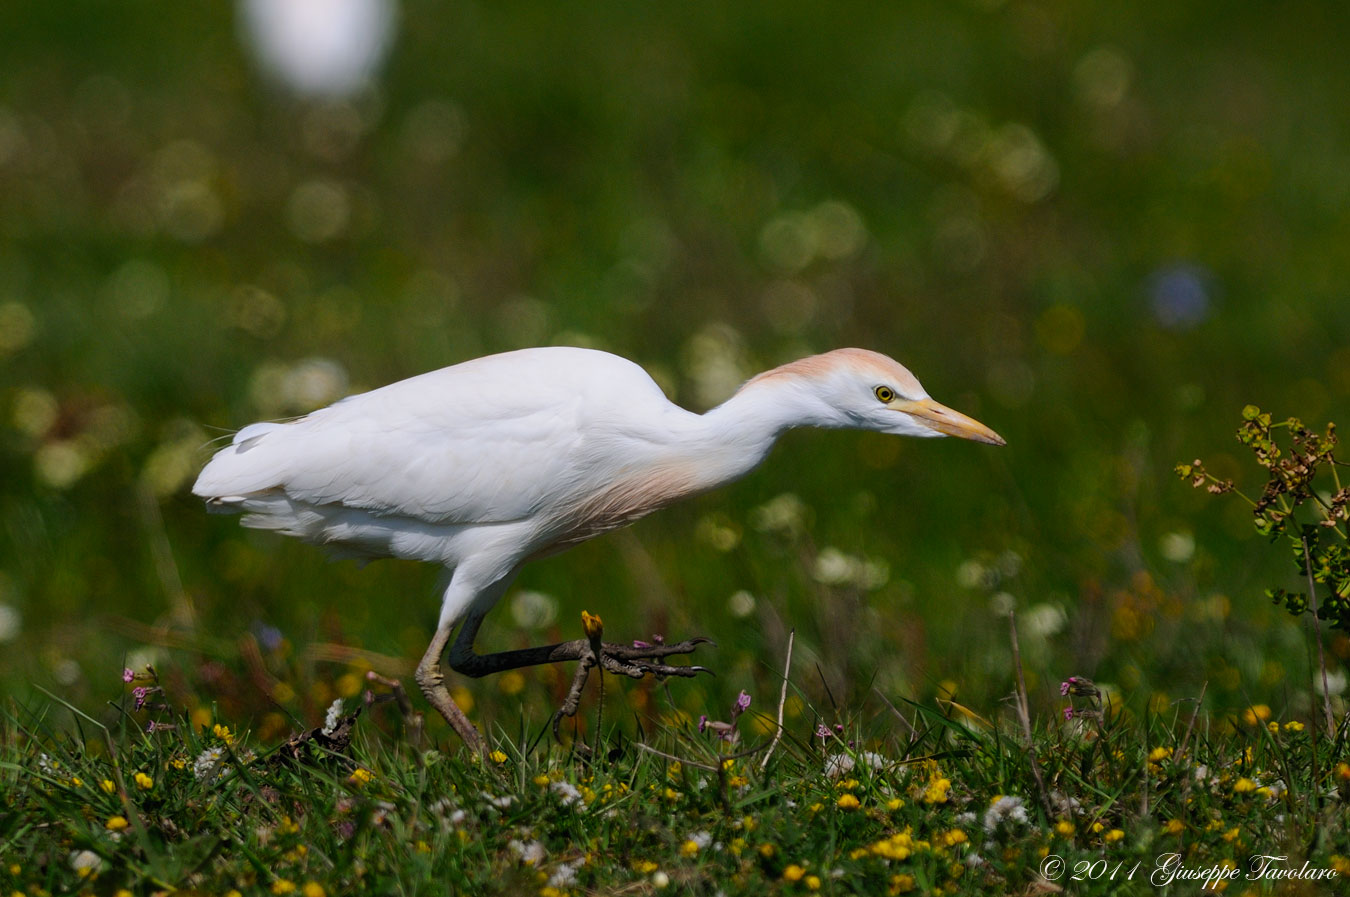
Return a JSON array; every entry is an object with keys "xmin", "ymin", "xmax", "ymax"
[{"xmin": 0, "ymin": 651, "xmax": 1350, "ymax": 897}]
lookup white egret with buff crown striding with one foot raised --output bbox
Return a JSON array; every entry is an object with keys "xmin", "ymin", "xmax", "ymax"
[{"xmin": 192, "ymin": 347, "xmax": 1004, "ymax": 748}]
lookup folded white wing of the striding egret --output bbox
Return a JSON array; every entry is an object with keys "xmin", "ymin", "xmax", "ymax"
[{"xmin": 193, "ymin": 344, "xmax": 664, "ymax": 524}]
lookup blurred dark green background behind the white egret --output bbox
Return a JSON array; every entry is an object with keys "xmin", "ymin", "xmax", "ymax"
[{"xmin": 0, "ymin": 0, "xmax": 1350, "ymax": 736}]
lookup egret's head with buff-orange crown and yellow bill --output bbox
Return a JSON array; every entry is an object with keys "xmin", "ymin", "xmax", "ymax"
[{"xmin": 745, "ymin": 349, "xmax": 1007, "ymax": 446}]
